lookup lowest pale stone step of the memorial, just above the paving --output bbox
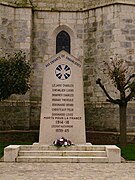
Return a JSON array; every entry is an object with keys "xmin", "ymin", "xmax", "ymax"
[{"xmin": 16, "ymin": 156, "xmax": 109, "ymax": 163}]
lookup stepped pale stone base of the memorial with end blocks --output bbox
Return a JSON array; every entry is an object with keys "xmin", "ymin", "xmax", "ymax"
[{"xmin": 4, "ymin": 144, "xmax": 121, "ymax": 163}]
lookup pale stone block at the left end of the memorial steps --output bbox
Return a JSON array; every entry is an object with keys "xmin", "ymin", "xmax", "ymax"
[{"xmin": 4, "ymin": 145, "xmax": 20, "ymax": 162}]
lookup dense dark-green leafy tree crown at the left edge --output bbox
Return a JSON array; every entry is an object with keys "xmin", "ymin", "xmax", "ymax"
[{"xmin": 0, "ymin": 51, "xmax": 31, "ymax": 101}]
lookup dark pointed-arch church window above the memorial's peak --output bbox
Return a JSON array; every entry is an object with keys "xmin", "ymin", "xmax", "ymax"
[{"xmin": 56, "ymin": 31, "xmax": 70, "ymax": 54}]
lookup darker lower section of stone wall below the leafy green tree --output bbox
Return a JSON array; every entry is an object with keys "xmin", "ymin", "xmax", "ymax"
[{"xmin": 0, "ymin": 101, "xmax": 30, "ymax": 130}]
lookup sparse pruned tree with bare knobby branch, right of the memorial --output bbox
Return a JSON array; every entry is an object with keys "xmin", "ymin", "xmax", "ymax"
[{"xmin": 96, "ymin": 55, "xmax": 135, "ymax": 146}]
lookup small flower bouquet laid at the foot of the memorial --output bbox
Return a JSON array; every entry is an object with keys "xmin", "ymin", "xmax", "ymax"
[{"xmin": 53, "ymin": 137, "xmax": 73, "ymax": 147}]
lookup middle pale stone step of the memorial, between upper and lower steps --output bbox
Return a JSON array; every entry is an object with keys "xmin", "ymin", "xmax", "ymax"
[{"xmin": 19, "ymin": 150, "xmax": 107, "ymax": 157}]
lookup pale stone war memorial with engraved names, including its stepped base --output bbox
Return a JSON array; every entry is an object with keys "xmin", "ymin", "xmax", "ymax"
[{"xmin": 4, "ymin": 51, "xmax": 121, "ymax": 163}]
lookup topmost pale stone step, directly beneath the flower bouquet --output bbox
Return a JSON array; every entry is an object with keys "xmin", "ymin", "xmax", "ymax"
[{"xmin": 20, "ymin": 145, "xmax": 106, "ymax": 151}]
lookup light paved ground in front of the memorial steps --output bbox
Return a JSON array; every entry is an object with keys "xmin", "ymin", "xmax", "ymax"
[{"xmin": 0, "ymin": 162, "xmax": 135, "ymax": 180}]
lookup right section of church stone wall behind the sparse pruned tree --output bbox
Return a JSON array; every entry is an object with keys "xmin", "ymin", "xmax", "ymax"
[{"xmin": 84, "ymin": 5, "xmax": 135, "ymax": 131}]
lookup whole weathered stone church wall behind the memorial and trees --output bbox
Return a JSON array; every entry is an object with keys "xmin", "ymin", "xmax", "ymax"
[{"xmin": 0, "ymin": 1, "xmax": 135, "ymax": 131}]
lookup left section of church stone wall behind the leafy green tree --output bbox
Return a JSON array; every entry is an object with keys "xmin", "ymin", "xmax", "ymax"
[{"xmin": 0, "ymin": 5, "xmax": 31, "ymax": 130}]
